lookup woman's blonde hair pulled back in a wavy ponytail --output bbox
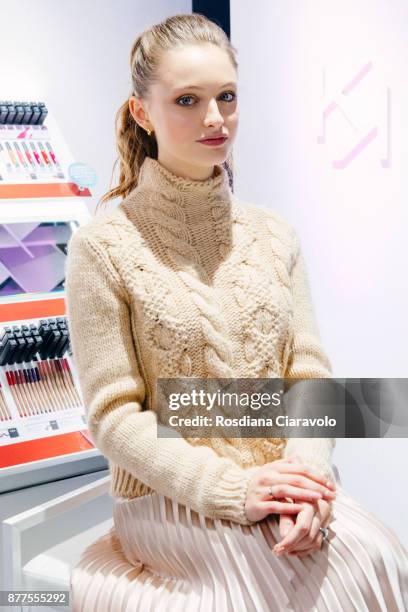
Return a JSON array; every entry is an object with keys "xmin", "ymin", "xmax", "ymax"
[{"xmin": 98, "ymin": 13, "xmax": 238, "ymax": 206}]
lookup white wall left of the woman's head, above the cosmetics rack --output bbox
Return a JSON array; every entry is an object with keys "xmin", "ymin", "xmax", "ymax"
[{"xmin": 0, "ymin": 0, "xmax": 191, "ymax": 210}]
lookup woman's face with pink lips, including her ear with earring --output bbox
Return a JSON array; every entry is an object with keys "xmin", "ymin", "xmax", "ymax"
[{"xmin": 129, "ymin": 43, "xmax": 238, "ymax": 180}]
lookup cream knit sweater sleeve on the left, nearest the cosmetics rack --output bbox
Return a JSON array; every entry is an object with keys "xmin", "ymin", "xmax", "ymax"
[{"xmin": 65, "ymin": 228, "xmax": 252, "ymax": 525}]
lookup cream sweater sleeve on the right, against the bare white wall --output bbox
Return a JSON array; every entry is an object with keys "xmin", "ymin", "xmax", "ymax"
[{"xmin": 284, "ymin": 232, "xmax": 336, "ymax": 482}]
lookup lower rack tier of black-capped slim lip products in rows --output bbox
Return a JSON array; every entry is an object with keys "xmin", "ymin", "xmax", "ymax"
[{"xmin": 0, "ymin": 317, "xmax": 92, "ymax": 462}]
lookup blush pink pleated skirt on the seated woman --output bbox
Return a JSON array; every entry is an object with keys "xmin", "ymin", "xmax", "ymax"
[{"xmin": 71, "ymin": 486, "xmax": 408, "ymax": 612}]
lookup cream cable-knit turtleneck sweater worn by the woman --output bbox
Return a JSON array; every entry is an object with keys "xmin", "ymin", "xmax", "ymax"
[{"xmin": 66, "ymin": 157, "xmax": 335, "ymax": 524}]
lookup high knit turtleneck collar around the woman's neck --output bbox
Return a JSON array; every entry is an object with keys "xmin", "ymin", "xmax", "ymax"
[{"xmin": 136, "ymin": 157, "xmax": 232, "ymax": 224}]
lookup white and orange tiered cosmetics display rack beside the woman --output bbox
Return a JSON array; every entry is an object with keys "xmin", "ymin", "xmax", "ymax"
[{"xmin": 0, "ymin": 100, "xmax": 107, "ymax": 492}]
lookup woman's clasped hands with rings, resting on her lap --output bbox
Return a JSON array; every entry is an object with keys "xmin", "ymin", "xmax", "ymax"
[{"xmin": 245, "ymin": 455, "xmax": 336, "ymax": 557}]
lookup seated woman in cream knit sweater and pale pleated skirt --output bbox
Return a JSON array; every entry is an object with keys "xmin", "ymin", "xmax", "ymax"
[{"xmin": 66, "ymin": 14, "xmax": 408, "ymax": 612}]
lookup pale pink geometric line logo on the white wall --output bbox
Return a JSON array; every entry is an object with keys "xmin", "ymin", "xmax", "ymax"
[{"xmin": 317, "ymin": 61, "xmax": 391, "ymax": 170}]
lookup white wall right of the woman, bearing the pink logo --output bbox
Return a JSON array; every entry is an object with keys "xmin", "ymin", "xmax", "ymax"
[{"xmin": 231, "ymin": 0, "xmax": 408, "ymax": 544}]
